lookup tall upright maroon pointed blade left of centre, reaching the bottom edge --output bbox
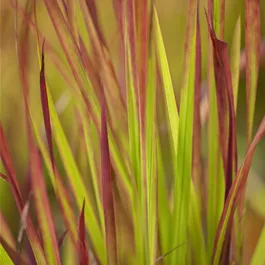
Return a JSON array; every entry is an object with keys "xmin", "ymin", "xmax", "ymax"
[{"xmin": 100, "ymin": 89, "xmax": 118, "ymax": 265}]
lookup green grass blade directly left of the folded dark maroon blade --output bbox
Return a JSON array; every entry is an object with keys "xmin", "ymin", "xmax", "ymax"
[{"xmin": 206, "ymin": 0, "xmax": 225, "ymax": 262}]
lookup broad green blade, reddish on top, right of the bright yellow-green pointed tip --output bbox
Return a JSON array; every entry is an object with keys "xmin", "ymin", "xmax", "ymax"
[{"xmin": 171, "ymin": 0, "xmax": 197, "ymax": 265}]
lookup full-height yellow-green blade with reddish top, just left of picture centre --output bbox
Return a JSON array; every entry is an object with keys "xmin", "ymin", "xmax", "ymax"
[{"xmin": 121, "ymin": 0, "xmax": 144, "ymax": 265}]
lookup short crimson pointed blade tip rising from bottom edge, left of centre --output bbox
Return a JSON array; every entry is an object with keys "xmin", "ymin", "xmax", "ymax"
[{"xmin": 78, "ymin": 201, "xmax": 90, "ymax": 265}]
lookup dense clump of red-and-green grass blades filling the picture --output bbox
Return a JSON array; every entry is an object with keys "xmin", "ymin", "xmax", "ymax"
[{"xmin": 0, "ymin": 0, "xmax": 265, "ymax": 265}]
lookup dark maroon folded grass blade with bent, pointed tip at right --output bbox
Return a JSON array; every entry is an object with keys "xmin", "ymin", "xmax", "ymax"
[{"xmin": 206, "ymin": 9, "xmax": 237, "ymax": 264}]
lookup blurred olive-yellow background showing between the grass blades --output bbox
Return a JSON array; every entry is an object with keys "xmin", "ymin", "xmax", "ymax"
[{"xmin": 0, "ymin": 0, "xmax": 265, "ymax": 264}]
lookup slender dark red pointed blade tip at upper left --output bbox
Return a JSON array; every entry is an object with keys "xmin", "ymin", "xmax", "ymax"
[{"xmin": 40, "ymin": 39, "xmax": 54, "ymax": 169}]
